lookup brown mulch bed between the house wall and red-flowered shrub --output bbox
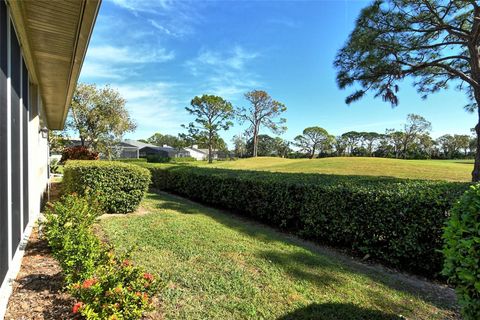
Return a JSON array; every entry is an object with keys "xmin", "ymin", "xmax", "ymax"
[{"xmin": 5, "ymin": 228, "xmax": 79, "ymax": 320}]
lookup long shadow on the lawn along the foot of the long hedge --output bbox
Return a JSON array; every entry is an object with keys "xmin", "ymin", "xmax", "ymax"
[{"xmin": 147, "ymin": 192, "xmax": 457, "ymax": 319}]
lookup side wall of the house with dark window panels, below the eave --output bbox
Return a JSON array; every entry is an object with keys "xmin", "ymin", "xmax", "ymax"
[{"xmin": 0, "ymin": 1, "xmax": 48, "ymax": 319}]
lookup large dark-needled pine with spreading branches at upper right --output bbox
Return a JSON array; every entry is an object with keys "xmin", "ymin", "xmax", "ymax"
[{"xmin": 334, "ymin": 0, "xmax": 480, "ymax": 181}]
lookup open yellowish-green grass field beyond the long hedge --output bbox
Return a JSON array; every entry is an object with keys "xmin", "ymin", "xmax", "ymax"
[{"xmin": 195, "ymin": 157, "xmax": 473, "ymax": 181}]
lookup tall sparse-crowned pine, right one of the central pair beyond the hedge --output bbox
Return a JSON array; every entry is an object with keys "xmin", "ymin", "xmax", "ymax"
[{"xmin": 237, "ymin": 90, "xmax": 287, "ymax": 157}]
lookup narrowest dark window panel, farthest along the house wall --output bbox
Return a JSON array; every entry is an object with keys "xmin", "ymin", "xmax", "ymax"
[{"xmin": 22, "ymin": 59, "xmax": 30, "ymax": 230}]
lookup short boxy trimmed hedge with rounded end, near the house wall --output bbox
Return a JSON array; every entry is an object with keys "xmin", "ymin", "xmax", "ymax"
[{"xmin": 63, "ymin": 160, "xmax": 150, "ymax": 213}]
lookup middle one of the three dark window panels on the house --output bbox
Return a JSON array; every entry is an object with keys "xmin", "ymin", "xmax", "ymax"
[{"xmin": 10, "ymin": 24, "xmax": 22, "ymax": 255}]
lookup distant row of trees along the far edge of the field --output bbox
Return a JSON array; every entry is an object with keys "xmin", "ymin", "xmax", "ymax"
[{"xmin": 233, "ymin": 114, "xmax": 476, "ymax": 159}]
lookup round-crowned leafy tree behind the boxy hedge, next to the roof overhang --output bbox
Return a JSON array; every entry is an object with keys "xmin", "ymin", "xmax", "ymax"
[{"xmin": 66, "ymin": 83, "xmax": 136, "ymax": 158}]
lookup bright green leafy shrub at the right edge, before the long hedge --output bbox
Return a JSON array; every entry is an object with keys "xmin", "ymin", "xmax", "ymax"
[{"xmin": 443, "ymin": 185, "xmax": 480, "ymax": 320}]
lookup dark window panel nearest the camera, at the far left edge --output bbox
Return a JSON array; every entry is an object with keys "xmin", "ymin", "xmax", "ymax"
[{"xmin": 0, "ymin": 1, "xmax": 9, "ymax": 283}]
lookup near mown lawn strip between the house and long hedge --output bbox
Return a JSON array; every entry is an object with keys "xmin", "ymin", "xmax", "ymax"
[{"xmin": 100, "ymin": 191, "xmax": 455, "ymax": 320}]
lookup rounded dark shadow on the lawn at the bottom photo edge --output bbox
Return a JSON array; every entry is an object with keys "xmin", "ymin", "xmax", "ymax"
[{"xmin": 277, "ymin": 303, "xmax": 405, "ymax": 320}]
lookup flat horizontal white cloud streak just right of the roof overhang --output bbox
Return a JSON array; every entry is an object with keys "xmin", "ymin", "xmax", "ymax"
[{"xmin": 87, "ymin": 45, "xmax": 175, "ymax": 64}]
